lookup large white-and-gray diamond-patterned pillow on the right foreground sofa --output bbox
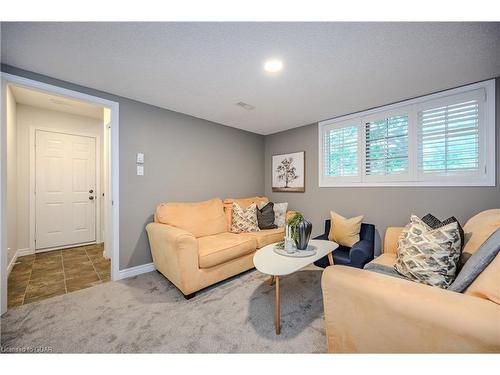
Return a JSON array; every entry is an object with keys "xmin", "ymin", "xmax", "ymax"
[{"xmin": 394, "ymin": 215, "xmax": 460, "ymax": 289}]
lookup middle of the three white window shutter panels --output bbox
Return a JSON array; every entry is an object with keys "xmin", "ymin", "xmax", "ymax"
[{"xmin": 365, "ymin": 115, "xmax": 408, "ymax": 176}]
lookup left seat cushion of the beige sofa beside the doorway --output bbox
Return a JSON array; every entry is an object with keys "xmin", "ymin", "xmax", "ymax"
[{"xmin": 198, "ymin": 232, "xmax": 257, "ymax": 268}]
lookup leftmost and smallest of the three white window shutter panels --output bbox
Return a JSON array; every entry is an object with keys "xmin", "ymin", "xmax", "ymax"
[{"xmin": 323, "ymin": 125, "xmax": 358, "ymax": 177}]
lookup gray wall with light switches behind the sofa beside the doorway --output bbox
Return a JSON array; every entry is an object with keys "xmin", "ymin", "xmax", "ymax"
[{"xmin": 2, "ymin": 65, "xmax": 264, "ymax": 269}]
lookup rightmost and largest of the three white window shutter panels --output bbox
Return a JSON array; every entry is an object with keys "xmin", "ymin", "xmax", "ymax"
[{"xmin": 417, "ymin": 91, "xmax": 484, "ymax": 176}]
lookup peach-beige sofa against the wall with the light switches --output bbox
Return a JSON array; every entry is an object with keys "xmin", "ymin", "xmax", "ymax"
[{"xmin": 146, "ymin": 197, "xmax": 284, "ymax": 298}]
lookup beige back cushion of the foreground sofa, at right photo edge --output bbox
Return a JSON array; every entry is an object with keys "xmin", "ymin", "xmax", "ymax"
[{"xmin": 462, "ymin": 208, "xmax": 500, "ymax": 260}]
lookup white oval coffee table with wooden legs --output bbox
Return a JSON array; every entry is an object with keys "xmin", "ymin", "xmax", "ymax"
[{"xmin": 253, "ymin": 240, "xmax": 339, "ymax": 335}]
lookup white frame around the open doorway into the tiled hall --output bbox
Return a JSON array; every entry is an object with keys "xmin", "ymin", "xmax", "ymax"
[{"xmin": 0, "ymin": 72, "xmax": 120, "ymax": 314}]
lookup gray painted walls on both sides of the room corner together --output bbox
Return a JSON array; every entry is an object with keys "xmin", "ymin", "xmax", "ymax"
[{"xmin": 2, "ymin": 65, "xmax": 500, "ymax": 269}]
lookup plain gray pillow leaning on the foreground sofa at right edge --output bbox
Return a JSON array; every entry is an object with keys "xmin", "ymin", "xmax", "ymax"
[{"xmin": 448, "ymin": 229, "xmax": 500, "ymax": 293}]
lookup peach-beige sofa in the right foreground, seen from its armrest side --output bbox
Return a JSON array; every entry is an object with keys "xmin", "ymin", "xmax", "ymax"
[{"xmin": 322, "ymin": 209, "xmax": 500, "ymax": 353}]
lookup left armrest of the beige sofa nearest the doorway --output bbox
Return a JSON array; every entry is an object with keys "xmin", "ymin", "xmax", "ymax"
[{"xmin": 146, "ymin": 223, "xmax": 199, "ymax": 295}]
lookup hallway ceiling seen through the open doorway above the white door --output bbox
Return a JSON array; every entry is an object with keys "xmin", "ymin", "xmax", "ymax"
[{"xmin": 11, "ymin": 86, "xmax": 104, "ymax": 120}]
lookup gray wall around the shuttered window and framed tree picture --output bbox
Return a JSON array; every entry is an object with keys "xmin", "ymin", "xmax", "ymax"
[{"xmin": 265, "ymin": 79, "xmax": 500, "ymax": 254}]
